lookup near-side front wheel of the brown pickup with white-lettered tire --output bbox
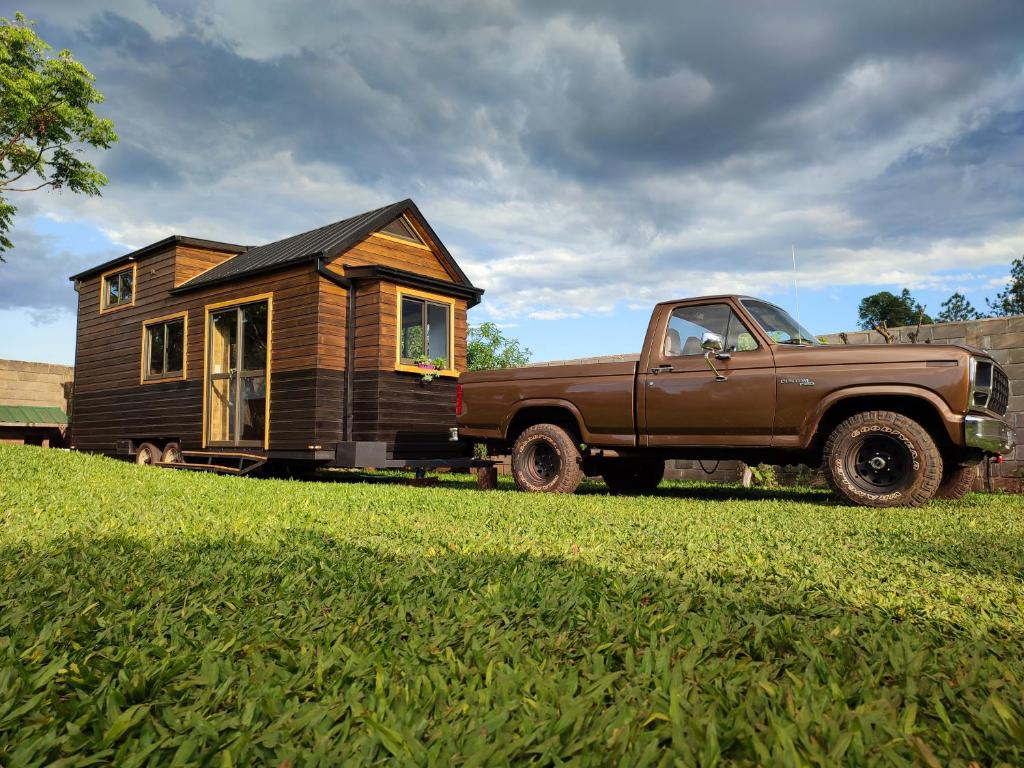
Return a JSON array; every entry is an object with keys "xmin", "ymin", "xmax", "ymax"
[{"xmin": 822, "ymin": 411, "xmax": 942, "ymax": 507}]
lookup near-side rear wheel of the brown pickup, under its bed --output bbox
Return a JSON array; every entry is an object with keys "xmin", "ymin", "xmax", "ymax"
[{"xmin": 512, "ymin": 424, "xmax": 583, "ymax": 494}]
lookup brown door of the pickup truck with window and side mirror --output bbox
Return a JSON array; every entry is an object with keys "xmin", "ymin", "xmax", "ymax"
[{"xmin": 638, "ymin": 299, "xmax": 775, "ymax": 446}]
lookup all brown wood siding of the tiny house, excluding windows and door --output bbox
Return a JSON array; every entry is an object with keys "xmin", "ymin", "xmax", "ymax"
[{"xmin": 72, "ymin": 221, "xmax": 475, "ymax": 458}]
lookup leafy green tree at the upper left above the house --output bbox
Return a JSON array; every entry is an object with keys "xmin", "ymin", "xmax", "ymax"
[{"xmin": 0, "ymin": 13, "xmax": 118, "ymax": 261}]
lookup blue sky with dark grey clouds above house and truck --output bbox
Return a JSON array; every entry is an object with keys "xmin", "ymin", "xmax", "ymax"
[{"xmin": 0, "ymin": 0, "xmax": 1024, "ymax": 362}]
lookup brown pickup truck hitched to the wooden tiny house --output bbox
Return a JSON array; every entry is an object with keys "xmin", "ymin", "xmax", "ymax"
[{"xmin": 457, "ymin": 296, "xmax": 1014, "ymax": 507}]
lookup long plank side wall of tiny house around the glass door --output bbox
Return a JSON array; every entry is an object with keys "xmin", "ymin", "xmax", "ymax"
[{"xmin": 72, "ymin": 247, "xmax": 319, "ymax": 451}]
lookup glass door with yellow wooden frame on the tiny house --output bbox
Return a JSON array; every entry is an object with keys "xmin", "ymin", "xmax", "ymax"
[{"xmin": 207, "ymin": 301, "xmax": 269, "ymax": 446}]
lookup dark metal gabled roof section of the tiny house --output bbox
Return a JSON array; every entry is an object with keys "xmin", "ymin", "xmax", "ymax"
[{"xmin": 172, "ymin": 200, "xmax": 472, "ymax": 293}]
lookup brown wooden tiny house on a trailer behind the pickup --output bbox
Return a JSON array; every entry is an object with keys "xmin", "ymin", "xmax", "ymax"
[{"xmin": 71, "ymin": 200, "xmax": 482, "ymax": 467}]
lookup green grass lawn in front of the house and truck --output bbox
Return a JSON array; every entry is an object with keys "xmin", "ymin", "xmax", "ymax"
[{"xmin": 0, "ymin": 446, "xmax": 1024, "ymax": 767}]
